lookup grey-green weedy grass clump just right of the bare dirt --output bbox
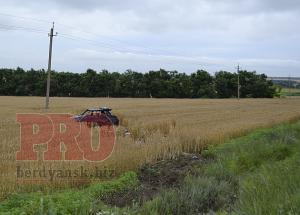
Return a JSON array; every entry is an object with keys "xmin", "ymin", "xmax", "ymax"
[{"xmin": 141, "ymin": 176, "xmax": 234, "ymax": 215}]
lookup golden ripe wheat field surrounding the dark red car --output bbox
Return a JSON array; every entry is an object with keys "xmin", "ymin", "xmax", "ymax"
[{"xmin": 0, "ymin": 97, "xmax": 300, "ymax": 198}]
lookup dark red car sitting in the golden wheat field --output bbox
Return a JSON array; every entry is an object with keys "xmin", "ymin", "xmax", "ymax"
[{"xmin": 73, "ymin": 107, "xmax": 119, "ymax": 126}]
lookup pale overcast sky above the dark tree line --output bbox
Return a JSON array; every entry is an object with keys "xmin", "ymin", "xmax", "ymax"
[{"xmin": 0, "ymin": 0, "xmax": 300, "ymax": 77}]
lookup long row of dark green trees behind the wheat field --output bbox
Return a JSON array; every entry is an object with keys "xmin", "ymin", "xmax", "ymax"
[{"xmin": 0, "ymin": 68, "xmax": 278, "ymax": 98}]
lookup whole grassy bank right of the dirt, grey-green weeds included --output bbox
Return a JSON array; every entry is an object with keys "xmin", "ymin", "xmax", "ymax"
[{"xmin": 142, "ymin": 123, "xmax": 300, "ymax": 215}]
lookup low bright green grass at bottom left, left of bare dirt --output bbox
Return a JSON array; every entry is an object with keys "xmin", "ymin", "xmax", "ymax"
[{"xmin": 0, "ymin": 172, "xmax": 138, "ymax": 215}]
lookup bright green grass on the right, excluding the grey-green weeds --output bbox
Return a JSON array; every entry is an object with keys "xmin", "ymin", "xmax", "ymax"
[{"xmin": 204, "ymin": 123, "xmax": 300, "ymax": 214}]
